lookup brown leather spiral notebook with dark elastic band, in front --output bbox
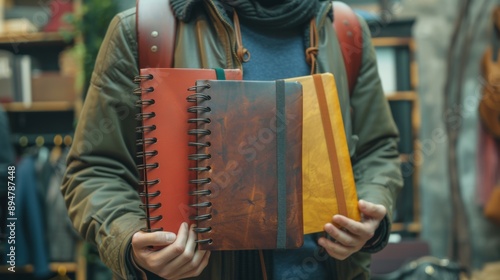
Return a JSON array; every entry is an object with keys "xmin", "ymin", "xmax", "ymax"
[{"xmin": 188, "ymin": 80, "xmax": 303, "ymax": 250}]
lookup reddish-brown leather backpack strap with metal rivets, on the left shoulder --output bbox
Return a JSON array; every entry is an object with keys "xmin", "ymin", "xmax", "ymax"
[{"xmin": 136, "ymin": 0, "xmax": 176, "ymax": 69}]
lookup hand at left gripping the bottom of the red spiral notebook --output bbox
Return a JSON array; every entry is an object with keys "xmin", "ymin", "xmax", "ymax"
[{"xmin": 132, "ymin": 223, "xmax": 210, "ymax": 279}]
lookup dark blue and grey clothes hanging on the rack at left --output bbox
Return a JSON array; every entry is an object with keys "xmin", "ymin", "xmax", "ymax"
[{"xmin": 3, "ymin": 145, "xmax": 80, "ymax": 278}]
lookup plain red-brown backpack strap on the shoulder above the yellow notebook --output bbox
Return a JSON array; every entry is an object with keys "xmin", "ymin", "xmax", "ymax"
[{"xmin": 333, "ymin": 1, "xmax": 363, "ymax": 94}]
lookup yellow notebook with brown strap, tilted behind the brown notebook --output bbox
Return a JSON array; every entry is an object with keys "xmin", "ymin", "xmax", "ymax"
[{"xmin": 287, "ymin": 73, "xmax": 360, "ymax": 234}]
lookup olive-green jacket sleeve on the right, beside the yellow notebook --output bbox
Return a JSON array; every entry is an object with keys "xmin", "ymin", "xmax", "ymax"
[{"xmin": 351, "ymin": 15, "xmax": 403, "ymax": 253}]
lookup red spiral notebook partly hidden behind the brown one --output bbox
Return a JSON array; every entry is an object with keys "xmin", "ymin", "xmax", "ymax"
[{"xmin": 138, "ymin": 68, "xmax": 242, "ymax": 233}]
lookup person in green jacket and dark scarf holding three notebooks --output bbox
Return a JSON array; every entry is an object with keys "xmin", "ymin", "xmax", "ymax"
[{"xmin": 63, "ymin": 0, "xmax": 402, "ymax": 279}]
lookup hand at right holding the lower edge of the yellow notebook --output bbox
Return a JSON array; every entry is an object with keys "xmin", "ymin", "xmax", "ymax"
[{"xmin": 318, "ymin": 200, "xmax": 387, "ymax": 260}]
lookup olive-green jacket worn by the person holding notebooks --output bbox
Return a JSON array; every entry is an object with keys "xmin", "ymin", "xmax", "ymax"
[{"xmin": 62, "ymin": 1, "xmax": 402, "ymax": 279}]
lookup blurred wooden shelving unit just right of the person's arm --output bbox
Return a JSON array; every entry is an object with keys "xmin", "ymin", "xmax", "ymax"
[{"xmin": 372, "ymin": 37, "xmax": 421, "ymax": 236}]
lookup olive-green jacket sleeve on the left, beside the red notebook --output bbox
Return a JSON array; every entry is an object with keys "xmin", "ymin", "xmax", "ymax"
[{"xmin": 62, "ymin": 10, "xmax": 145, "ymax": 278}]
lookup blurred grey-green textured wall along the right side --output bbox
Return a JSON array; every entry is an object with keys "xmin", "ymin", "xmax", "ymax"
[{"xmin": 407, "ymin": 0, "xmax": 500, "ymax": 269}]
